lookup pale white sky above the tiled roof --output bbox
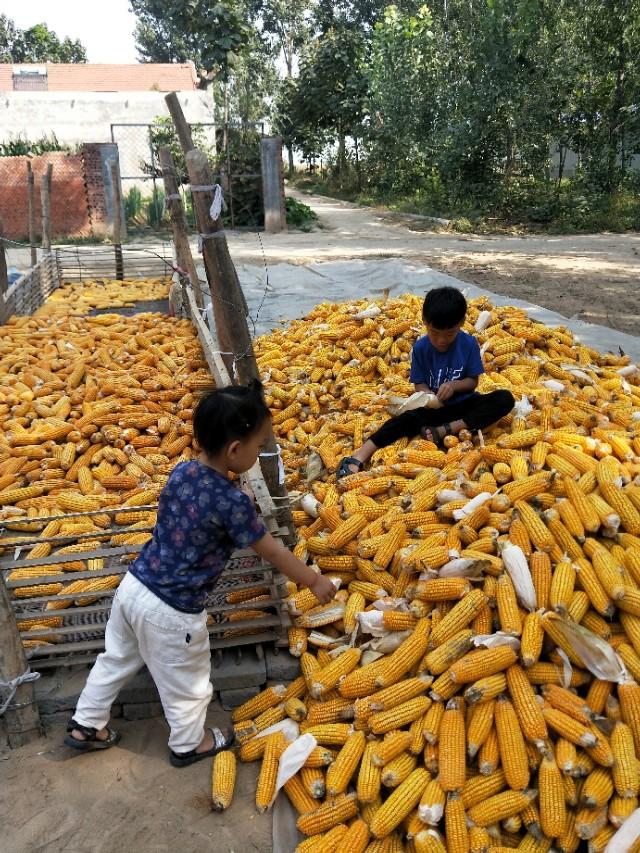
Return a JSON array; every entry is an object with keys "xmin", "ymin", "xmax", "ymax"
[{"xmin": 0, "ymin": 0, "xmax": 138, "ymax": 63}]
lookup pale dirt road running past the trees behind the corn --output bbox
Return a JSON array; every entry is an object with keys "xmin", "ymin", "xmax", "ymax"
[{"xmin": 229, "ymin": 189, "xmax": 640, "ymax": 335}]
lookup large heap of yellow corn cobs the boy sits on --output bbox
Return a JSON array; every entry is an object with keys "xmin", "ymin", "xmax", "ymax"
[{"xmin": 226, "ymin": 296, "xmax": 640, "ymax": 853}]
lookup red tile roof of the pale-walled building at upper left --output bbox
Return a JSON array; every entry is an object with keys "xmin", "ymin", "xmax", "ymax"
[{"xmin": 0, "ymin": 62, "xmax": 197, "ymax": 92}]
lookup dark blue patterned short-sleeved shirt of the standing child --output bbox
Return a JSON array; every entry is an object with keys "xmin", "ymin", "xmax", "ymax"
[{"xmin": 130, "ymin": 460, "xmax": 267, "ymax": 613}]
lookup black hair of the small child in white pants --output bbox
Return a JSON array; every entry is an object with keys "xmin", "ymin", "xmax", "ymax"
[{"xmin": 193, "ymin": 379, "xmax": 271, "ymax": 454}]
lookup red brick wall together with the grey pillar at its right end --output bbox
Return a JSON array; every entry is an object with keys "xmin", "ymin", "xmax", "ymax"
[{"xmin": 0, "ymin": 143, "xmax": 117, "ymax": 240}]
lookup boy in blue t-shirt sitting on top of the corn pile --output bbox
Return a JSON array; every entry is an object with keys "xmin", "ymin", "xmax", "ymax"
[{"xmin": 336, "ymin": 287, "xmax": 515, "ymax": 472}]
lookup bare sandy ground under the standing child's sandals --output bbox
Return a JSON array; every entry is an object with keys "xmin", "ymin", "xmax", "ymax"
[{"xmin": 0, "ymin": 706, "xmax": 272, "ymax": 853}]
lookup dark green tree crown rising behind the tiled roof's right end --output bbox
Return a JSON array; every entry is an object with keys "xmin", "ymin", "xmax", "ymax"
[{"xmin": 131, "ymin": 0, "xmax": 250, "ymax": 89}]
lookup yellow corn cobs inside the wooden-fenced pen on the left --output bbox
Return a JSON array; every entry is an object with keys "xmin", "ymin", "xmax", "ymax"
[{"xmin": 0, "ymin": 281, "xmax": 212, "ymax": 624}]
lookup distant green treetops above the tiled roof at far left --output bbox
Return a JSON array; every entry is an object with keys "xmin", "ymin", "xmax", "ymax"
[{"xmin": 0, "ymin": 15, "xmax": 87, "ymax": 64}]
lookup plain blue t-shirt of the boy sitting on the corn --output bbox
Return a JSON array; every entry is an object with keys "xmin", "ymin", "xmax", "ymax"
[{"xmin": 410, "ymin": 331, "xmax": 484, "ymax": 406}]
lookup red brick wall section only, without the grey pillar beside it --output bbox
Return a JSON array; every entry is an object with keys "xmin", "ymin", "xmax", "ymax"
[{"xmin": 0, "ymin": 151, "xmax": 91, "ymax": 240}]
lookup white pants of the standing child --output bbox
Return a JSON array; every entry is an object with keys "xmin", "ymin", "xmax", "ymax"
[{"xmin": 73, "ymin": 572, "xmax": 213, "ymax": 752}]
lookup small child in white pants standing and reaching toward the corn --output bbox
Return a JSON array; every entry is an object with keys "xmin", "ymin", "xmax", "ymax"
[{"xmin": 65, "ymin": 381, "xmax": 335, "ymax": 767}]
